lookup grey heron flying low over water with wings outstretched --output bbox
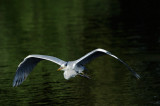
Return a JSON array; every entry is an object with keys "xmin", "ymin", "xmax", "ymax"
[{"xmin": 13, "ymin": 49, "xmax": 140, "ymax": 87}]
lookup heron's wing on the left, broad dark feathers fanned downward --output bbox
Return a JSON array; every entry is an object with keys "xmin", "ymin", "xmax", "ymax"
[{"xmin": 13, "ymin": 55, "xmax": 66, "ymax": 87}]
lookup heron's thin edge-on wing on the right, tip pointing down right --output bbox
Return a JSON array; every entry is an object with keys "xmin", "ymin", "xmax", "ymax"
[{"xmin": 75, "ymin": 49, "xmax": 140, "ymax": 79}]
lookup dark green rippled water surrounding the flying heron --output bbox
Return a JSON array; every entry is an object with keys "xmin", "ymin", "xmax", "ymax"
[{"xmin": 0, "ymin": 0, "xmax": 160, "ymax": 106}]
